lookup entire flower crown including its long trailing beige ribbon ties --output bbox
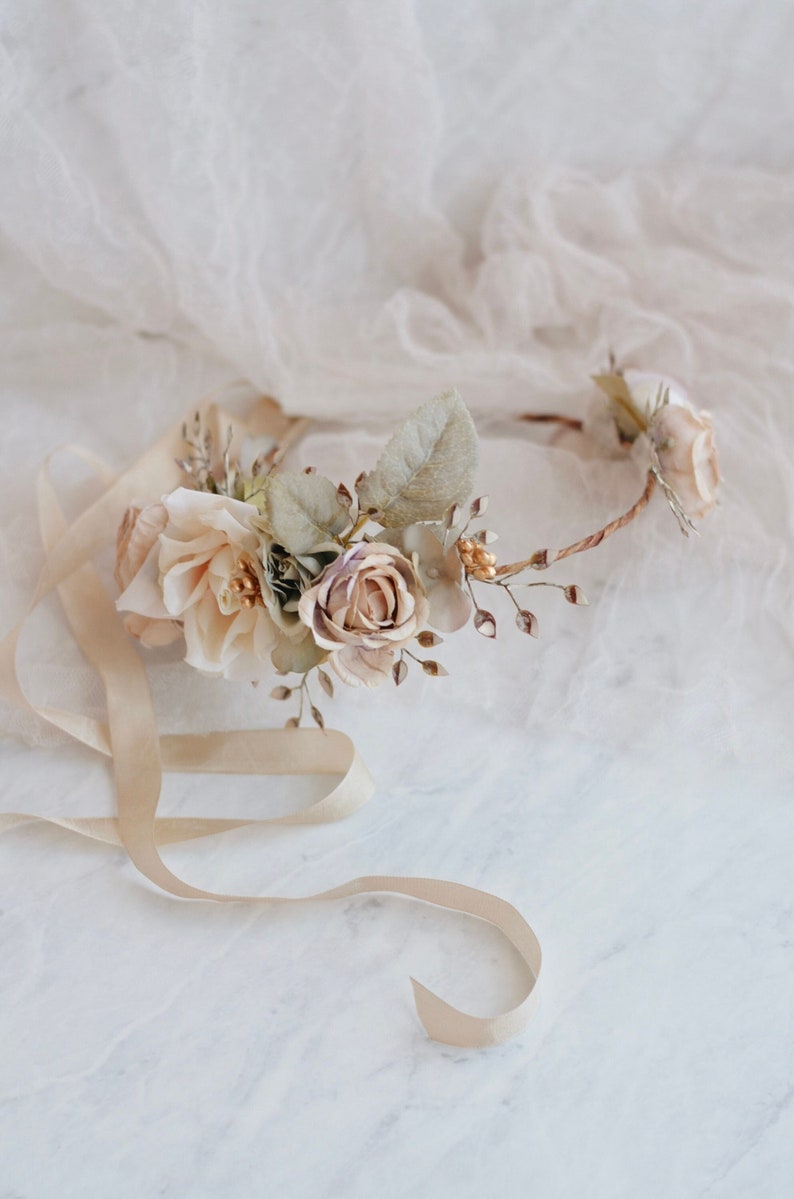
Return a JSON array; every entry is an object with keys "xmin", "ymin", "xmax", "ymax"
[{"xmin": 0, "ymin": 367, "xmax": 720, "ymax": 1047}]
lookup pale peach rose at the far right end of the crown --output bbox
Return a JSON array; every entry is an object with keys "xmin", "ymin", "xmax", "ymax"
[{"xmin": 648, "ymin": 393, "xmax": 720, "ymax": 520}]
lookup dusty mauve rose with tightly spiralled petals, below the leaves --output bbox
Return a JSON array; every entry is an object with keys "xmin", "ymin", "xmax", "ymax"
[{"xmin": 299, "ymin": 542, "xmax": 428, "ymax": 687}]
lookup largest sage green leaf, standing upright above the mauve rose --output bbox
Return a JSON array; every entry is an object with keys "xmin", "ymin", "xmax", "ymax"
[{"xmin": 356, "ymin": 391, "xmax": 477, "ymax": 529}]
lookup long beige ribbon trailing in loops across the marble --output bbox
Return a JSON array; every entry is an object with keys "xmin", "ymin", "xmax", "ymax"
[{"xmin": 0, "ymin": 399, "xmax": 541, "ymax": 1048}]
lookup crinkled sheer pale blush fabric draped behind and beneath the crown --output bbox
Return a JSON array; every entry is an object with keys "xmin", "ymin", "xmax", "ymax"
[{"xmin": 0, "ymin": 0, "xmax": 794, "ymax": 777}]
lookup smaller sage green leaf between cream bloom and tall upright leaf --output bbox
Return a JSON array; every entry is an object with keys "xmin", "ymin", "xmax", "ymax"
[{"xmin": 263, "ymin": 470, "xmax": 350, "ymax": 554}]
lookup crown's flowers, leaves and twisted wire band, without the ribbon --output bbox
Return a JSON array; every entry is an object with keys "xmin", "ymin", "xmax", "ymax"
[{"xmin": 116, "ymin": 369, "xmax": 718, "ymax": 727}]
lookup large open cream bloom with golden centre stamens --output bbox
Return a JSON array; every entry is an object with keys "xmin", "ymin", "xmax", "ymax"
[{"xmin": 118, "ymin": 487, "xmax": 276, "ymax": 679}]
